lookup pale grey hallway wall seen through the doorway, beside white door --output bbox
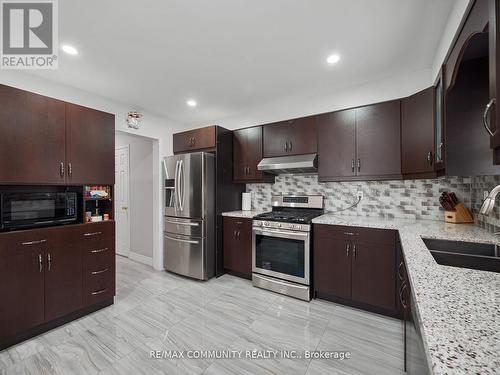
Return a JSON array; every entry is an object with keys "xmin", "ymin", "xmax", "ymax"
[{"xmin": 115, "ymin": 132, "xmax": 154, "ymax": 264}]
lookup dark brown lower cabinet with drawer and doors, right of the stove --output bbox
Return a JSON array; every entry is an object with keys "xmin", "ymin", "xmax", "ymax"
[{"xmin": 313, "ymin": 225, "xmax": 399, "ymax": 316}]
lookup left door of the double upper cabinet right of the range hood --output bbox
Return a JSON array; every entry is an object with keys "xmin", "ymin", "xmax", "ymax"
[{"xmin": 317, "ymin": 109, "xmax": 356, "ymax": 181}]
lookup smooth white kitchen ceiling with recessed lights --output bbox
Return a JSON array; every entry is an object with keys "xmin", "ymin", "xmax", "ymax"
[{"xmin": 29, "ymin": 0, "xmax": 454, "ymax": 126}]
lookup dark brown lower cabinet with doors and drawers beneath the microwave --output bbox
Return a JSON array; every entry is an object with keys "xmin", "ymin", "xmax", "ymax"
[{"xmin": 0, "ymin": 221, "xmax": 115, "ymax": 350}]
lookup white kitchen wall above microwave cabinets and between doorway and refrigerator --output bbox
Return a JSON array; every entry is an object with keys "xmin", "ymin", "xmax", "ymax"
[{"xmin": 0, "ymin": 70, "xmax": 182, "ymax": 269}]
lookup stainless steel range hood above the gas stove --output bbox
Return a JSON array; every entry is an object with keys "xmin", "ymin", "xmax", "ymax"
[{"xmin": 257, "ymin": 154, "xmax": 318, "ymax": 174}]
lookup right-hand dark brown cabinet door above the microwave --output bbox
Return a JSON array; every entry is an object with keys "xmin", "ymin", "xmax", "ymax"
[{"xmin": 66, "ymin": 103, "xmax": 115, "ymax": 185}]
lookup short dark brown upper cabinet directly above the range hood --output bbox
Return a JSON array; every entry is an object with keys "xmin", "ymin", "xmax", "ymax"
[{"xmin": 263, "ymin": 116, "xmax": 318, "ymax": 158}]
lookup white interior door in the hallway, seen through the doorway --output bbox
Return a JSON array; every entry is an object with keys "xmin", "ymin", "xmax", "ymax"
[{"xmin": 115, "ymin": 146, "xmax": 130, "ymax": 257}]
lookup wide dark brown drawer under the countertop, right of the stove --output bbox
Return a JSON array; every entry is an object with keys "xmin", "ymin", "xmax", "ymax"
[{"xmin": 314, "ymin": 224, "xmax": 396, "ymax": 245}]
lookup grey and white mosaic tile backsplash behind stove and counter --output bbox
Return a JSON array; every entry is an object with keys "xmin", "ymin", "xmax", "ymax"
[{"xmin": 247, "ymin": 175, "xmax": 500, "ymax": 230}]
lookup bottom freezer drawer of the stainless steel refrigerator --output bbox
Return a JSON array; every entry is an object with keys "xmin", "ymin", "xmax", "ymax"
[{"xmin": 163, "ymin": 233, "xmax": 207, "ymax": 280}]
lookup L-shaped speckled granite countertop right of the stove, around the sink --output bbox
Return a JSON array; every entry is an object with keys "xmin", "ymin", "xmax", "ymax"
[{"xmin": 313, "ymin": 214, "xmax": 500, "ymax": 374}]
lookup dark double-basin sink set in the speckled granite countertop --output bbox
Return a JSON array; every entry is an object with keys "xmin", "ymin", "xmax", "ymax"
[{"xmin": 422, "ymin": 238, "xmax": 500, "ymax": 272}]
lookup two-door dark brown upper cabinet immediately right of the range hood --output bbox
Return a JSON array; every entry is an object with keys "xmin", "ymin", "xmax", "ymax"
[{"xmin": 318, "ymin": 100, "xmax": 401, "ymax": 181}]
